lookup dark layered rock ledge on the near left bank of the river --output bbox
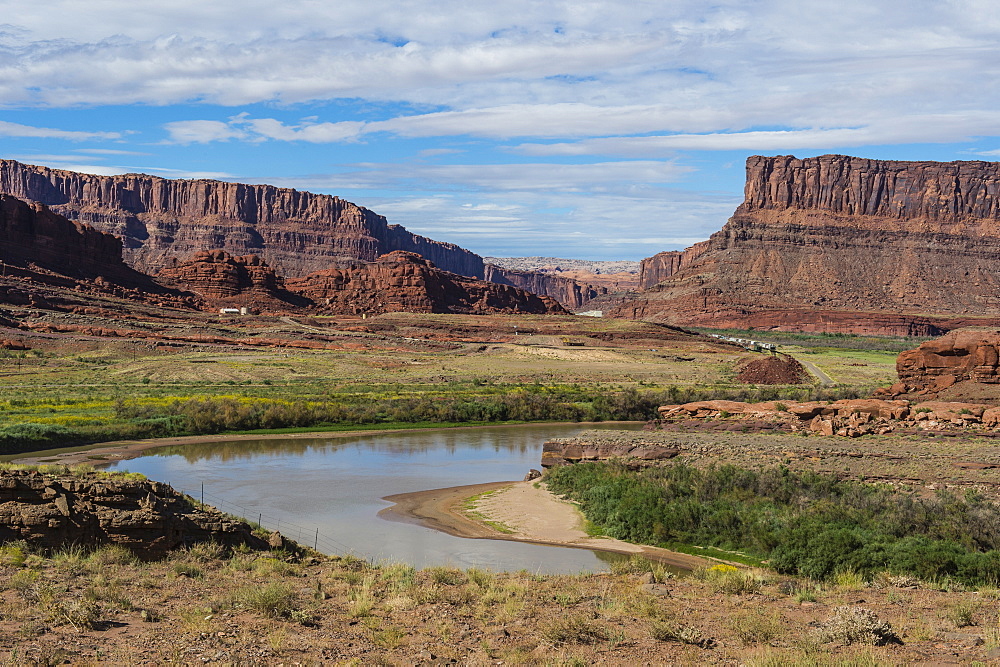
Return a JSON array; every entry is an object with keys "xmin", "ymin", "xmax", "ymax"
[{"xmin": 0, "ymin": 470, "xmax": 268, "ymax": 559}]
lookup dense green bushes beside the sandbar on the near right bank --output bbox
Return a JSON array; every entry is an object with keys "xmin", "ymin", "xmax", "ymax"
[{"xmin": 546, "ymin": 463, "xmax": 1000, "ymax": 586}]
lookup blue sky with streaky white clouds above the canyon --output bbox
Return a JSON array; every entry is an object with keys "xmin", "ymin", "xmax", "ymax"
[{"xmin": 0, "ymin": 0, "xmax": 1000, "ymax": 260}]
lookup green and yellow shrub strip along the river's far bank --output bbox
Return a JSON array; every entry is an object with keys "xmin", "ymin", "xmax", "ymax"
[{"xmin": 0, "ymin": 381, "xmax": 876, "ymax": 455}]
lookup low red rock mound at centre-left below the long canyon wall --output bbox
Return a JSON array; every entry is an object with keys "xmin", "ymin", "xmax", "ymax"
[{"xmin": 288, "ymin": 251, "xmax": 565, "ymax": 315}]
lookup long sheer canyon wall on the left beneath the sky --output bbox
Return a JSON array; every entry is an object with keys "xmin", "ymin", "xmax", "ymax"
[{"xmin": 0, "ymin": 160, "xmax": 483, "ymax": 278}]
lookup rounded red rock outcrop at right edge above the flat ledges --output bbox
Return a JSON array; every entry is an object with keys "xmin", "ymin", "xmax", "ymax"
[{"xmin": 890, "ymin": 328, "xmax": 1000, "ymax": 396}]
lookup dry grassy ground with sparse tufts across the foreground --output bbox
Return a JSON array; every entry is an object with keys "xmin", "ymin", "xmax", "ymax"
[{"xmin": 0, "ymin": 545, "xmax": 1000, "ymax": 665}]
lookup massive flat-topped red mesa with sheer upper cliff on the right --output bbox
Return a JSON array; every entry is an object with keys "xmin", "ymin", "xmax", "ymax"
[{"xmin": 612, "ymin": 155, "xmax": 1000, "ymax": 335}]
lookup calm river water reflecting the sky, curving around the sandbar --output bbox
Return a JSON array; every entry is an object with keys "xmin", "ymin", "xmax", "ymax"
[{"xmin": 112, "ymin": 424, "xmax": 637, "ymax": 573}]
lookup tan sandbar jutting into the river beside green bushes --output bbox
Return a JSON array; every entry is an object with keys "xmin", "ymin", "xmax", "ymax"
[{"xmin": 379, "ymin": 482, "xmax": 710, "ymax": 570}]
